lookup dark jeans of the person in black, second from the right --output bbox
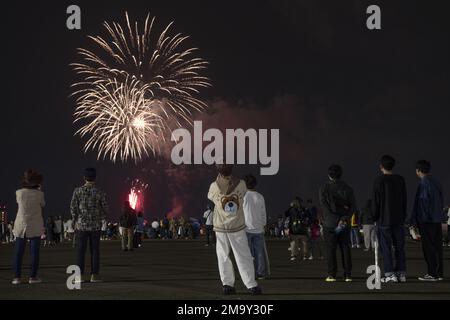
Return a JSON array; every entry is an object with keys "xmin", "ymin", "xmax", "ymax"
[{"xmin": 377, "ymin": 225, "xmax": 406, "ymax": 277}]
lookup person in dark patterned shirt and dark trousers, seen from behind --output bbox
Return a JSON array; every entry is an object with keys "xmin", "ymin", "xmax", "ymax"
[{"xmin": 70, "ymin": 168, "xmax": 108, "ymax": 282}]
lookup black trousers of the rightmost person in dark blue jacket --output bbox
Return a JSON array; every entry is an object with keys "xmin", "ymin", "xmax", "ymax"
[{"xmin": 419, "ymin": 223, "xmax": 444, "ymax": 278}]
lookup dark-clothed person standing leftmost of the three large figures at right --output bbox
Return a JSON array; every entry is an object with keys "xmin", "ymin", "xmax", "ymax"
[{"xmin": 319, "ymin": 164, "xmax": 356, "ymax": 282}]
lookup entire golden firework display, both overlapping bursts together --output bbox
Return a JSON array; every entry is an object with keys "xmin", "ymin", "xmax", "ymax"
[{"xmin": 72, "ymin": 13, "xmax": 210, "ymax": 161}]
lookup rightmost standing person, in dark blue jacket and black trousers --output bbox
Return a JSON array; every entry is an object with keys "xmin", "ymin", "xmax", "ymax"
[{"xmin": 408, "ymin": 160, "xmax": 446, "ymax": 282}]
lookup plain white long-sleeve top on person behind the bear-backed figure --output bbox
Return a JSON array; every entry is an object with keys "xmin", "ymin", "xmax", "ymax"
[{"xmin": 244, "ymin": 190, "xmax": 267, "ymax": 233}]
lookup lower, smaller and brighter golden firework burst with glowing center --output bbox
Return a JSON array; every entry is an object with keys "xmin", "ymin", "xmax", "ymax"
[{"xmin": 75, "ymin": 80, "xmax": 165, "ymax": 161}]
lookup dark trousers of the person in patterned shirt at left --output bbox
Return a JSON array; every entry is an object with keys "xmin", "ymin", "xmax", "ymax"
[{"xmin": 77, "ymin": 230, "xmax": 101, "ymax": 275}]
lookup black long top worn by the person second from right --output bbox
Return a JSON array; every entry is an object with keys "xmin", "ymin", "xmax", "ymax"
[{"xmin": 372, "ymin": 174, "xmax": 406, "ymax": 226}]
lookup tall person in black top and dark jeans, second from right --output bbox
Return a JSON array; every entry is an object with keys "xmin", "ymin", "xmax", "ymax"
[{"xmin": 372, "ymin": 155, "xmax": 406, "ymax": 283}]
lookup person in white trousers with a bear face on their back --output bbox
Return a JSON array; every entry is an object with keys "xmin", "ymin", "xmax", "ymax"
[{"xmin": 208, "ymin": 164, "xmax": 262, "ymax": 295}]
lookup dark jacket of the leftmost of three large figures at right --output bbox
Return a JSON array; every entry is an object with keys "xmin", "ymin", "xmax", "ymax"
[{"xmin": 319, "ymin": 180, "xmax": 356, "ymax": 228}]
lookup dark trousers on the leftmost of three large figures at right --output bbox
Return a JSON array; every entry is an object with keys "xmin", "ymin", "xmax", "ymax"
[{"xmin": 323, "ymin": 227, "xmax": 352, "ymax": 278}]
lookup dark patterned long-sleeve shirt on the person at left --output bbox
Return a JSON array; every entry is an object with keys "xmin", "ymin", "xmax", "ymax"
[{"xmin": 70, "ymin": 182, "xmax": 108, "ymax": 231}]
